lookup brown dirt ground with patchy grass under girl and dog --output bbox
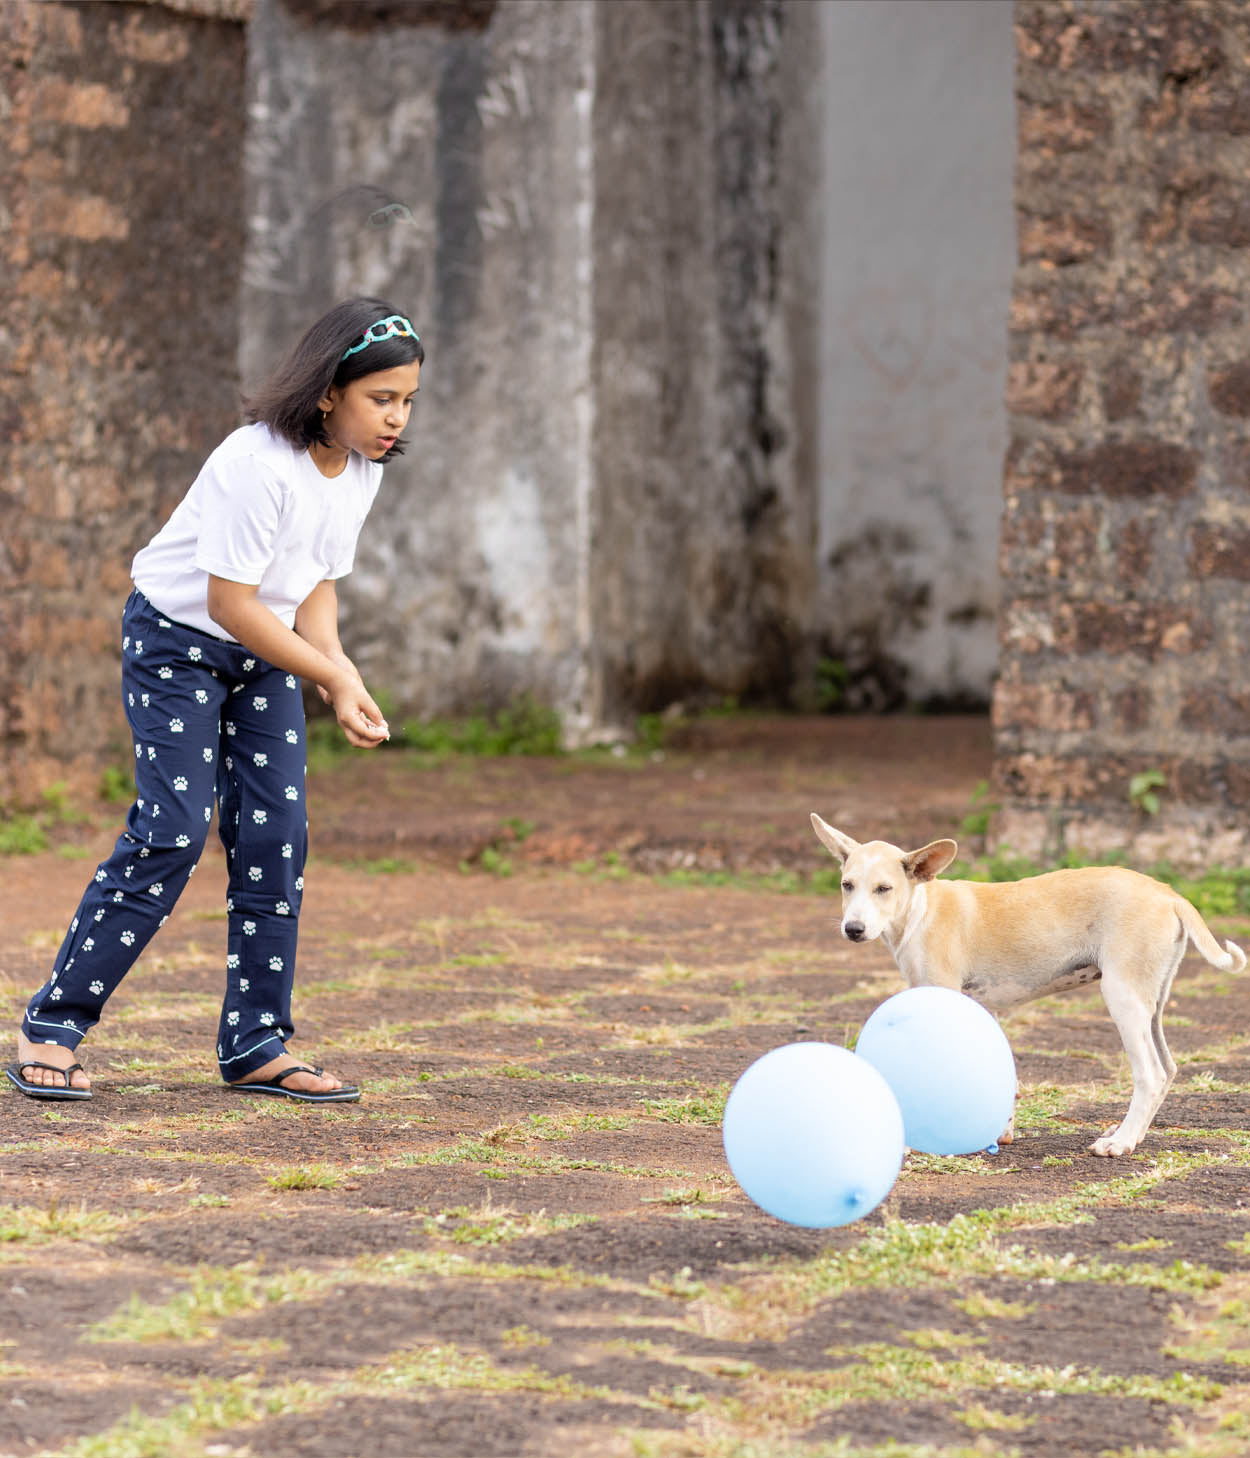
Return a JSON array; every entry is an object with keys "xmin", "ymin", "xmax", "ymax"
[{"xmin": 0, "ymin": 719, "xmax": 1250, "ymax": 1458}]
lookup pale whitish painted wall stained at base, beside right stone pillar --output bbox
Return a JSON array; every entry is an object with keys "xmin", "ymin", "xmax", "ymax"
[{"xmin": 818, "ymin": 0, "xmax": 1015, "ymax": 701}]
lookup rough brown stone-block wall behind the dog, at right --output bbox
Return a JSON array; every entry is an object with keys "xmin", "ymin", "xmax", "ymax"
[{"xmin": 993, "ymin": 0, "xmax": 1250, "ymax": 863}]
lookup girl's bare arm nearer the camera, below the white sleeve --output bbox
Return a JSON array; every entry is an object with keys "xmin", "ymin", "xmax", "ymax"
[{"xmin": 209, "ymin": 574, "xmax": 387, "ymax": 749}]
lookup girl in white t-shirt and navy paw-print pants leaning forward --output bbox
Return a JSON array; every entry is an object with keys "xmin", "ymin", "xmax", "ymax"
[{"xmin": 4, "ymin": 299, "xmax": 424, "ymax": 1102}]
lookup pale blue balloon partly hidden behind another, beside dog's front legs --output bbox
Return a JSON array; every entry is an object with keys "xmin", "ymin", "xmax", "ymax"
[{"xmin": 855, "ymin": 987, "xmax": 1015, "ymax": 1155}]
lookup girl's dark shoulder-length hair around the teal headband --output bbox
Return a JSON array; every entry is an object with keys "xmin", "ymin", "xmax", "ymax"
[{"xmin": 244, "ymin": 297, "xmax": 426, "ymax": 462}]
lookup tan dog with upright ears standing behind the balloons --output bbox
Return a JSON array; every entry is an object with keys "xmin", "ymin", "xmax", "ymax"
[{"xmin": 811, "ymin": 815, "xmax": 1246, "ymax": 1155}]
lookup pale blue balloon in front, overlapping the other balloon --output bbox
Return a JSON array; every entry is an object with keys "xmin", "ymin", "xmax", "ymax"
[{"xmin": 723, "ymin": 1042, "xmax": 903, "ymax": 1229}]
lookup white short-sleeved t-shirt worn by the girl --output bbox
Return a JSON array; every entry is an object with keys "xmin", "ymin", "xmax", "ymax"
[{"xmin": 130, "ymin": 424, "xmax": 382, "ymax": 642}]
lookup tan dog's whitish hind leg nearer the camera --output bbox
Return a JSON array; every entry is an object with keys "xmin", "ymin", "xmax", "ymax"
[{"xmin": 1090, "ymin": 940, "xmax": 1184, "ymax": 1156}]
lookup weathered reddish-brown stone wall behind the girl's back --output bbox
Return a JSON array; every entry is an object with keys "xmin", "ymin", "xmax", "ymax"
[{"xmin": 0, "ymin": 0, "xmax": 244, "ymax": 802}]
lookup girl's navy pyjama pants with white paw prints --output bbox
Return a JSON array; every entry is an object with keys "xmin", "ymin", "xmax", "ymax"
[{"xmin": 22, "ymin": 592, "xmax": 308, "ymax": 1080}]
